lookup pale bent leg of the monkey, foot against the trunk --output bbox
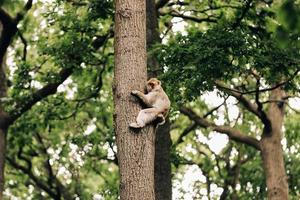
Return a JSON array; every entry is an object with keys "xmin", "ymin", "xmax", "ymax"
[{"xmin": 129, "ymin": 108, "xmax": 158, "ymax": 128}]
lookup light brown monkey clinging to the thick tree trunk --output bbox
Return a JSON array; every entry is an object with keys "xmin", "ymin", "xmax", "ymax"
[{"xmin": 129, "ymin": 78, "xmax": 171, "ymax": 128}]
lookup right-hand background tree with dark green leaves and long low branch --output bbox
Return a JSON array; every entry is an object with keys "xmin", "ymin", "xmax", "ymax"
[{"xmin": 156, "ymin": 1, "xmax": 299, "ymax": 199}]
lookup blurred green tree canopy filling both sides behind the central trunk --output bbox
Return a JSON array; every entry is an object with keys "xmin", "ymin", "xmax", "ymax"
[{"xmin": 0, "ymin": 0, "xmax": 300, "ymax": 200}]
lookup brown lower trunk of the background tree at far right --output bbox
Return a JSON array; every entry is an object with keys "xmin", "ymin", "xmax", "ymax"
[{"xmin": 261, "ymin": 88, "xmax": 289, "ymax": 200}]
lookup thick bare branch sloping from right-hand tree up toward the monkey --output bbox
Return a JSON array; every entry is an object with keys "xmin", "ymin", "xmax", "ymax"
[{"xmin": 180, "ymin": 107, "xmax": 261, "ymax": 150}]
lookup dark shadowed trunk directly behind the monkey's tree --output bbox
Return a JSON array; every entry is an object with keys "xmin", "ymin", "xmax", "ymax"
[{"xmin": 146, "ymin": 0, "xmax": 172, "ymax": 200}]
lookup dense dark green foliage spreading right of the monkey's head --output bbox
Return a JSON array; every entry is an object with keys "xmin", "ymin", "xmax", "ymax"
[{"xmin": 156, "ymin": 25, "xmax": 299, "ymax": 101}]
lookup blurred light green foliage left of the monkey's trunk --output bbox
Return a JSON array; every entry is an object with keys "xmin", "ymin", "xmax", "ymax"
[{"xmin": 6, "ymin": 1, "xmax": 118, "ymax": 199}]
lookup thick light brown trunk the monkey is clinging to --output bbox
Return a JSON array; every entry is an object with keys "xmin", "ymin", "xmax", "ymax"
[{"xmin": 113, "ymin": 0, "xmax": 155, "ymax": 200}]
